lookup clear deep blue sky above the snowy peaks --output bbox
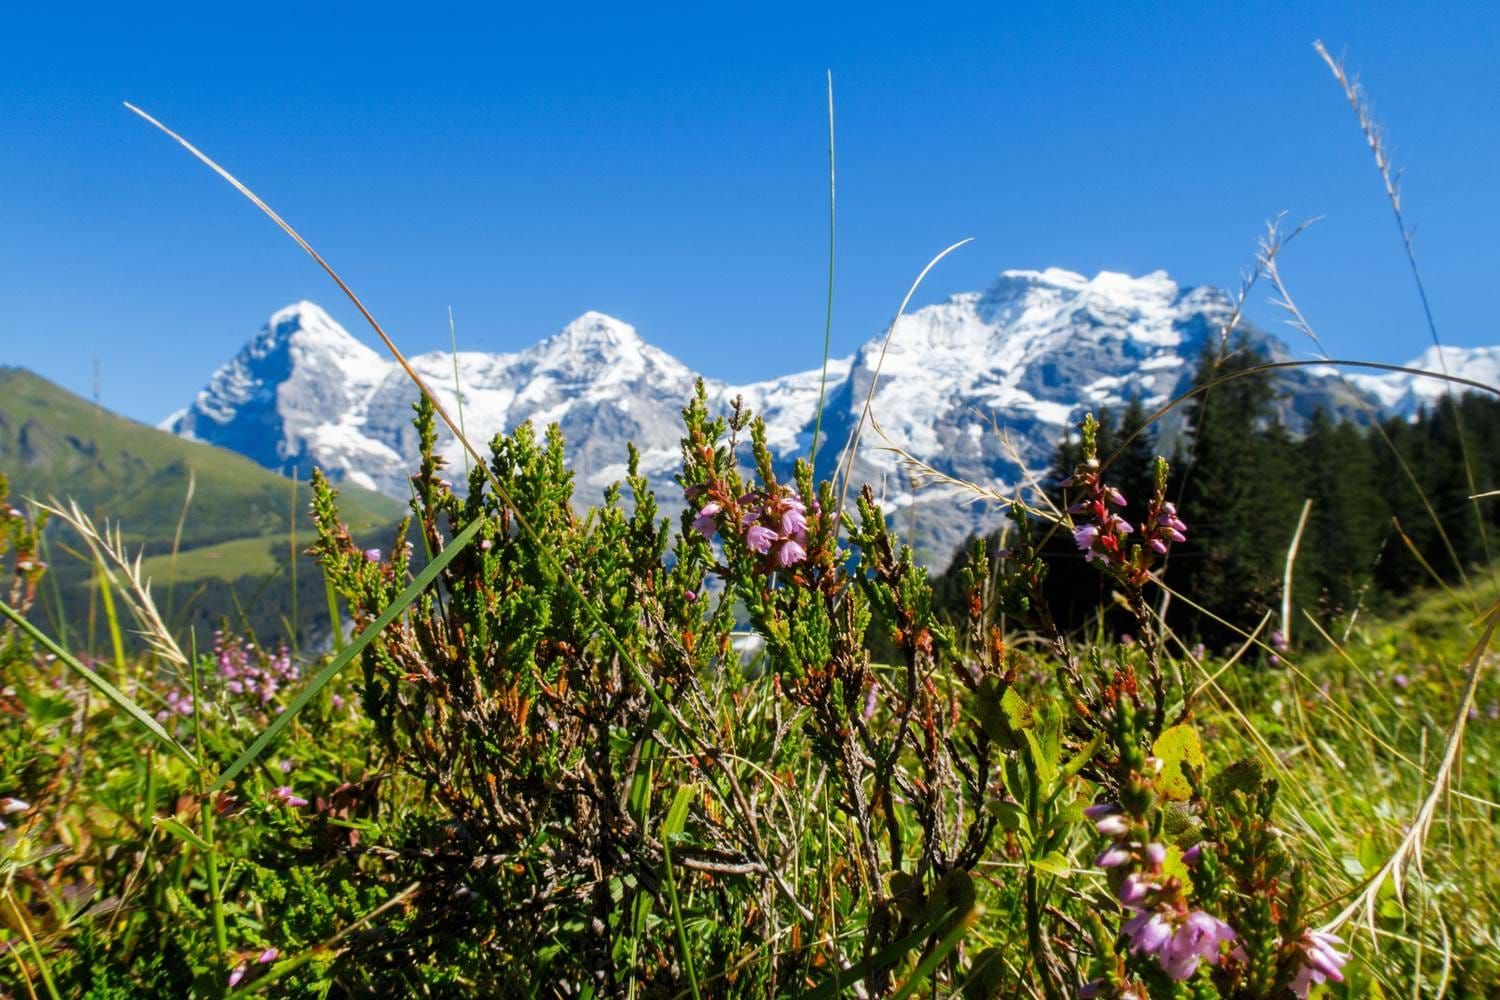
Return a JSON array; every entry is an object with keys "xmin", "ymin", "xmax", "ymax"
[{"xmin": 0, "ymin": 3, "xmax": 1500, "ymax": 421}]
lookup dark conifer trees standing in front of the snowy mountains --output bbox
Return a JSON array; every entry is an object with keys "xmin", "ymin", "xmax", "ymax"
[{"xmin": 938, "ymin": 337, "xmax": 1500, "ymax": 646}]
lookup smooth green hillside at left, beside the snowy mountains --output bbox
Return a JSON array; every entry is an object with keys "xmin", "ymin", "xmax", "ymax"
[{"xmin": 0, "ymin": 367, "xmax": 404, "ymax": 637}]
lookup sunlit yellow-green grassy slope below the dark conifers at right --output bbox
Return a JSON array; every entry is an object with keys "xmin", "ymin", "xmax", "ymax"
[{"xmin": 1197, "ymin": 567, "xmax": 1500, "ymax": 996}]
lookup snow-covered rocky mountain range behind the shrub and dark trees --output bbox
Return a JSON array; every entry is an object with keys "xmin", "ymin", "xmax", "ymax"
[{"xmin": 162, "ymin": 268, "xmax": 1464, "ymax": 564}]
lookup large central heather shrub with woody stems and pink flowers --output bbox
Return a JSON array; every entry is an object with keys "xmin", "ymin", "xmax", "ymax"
[{"xmin": 276, "ymin": 390, "xmax": 1347, "ymax": 997}]
